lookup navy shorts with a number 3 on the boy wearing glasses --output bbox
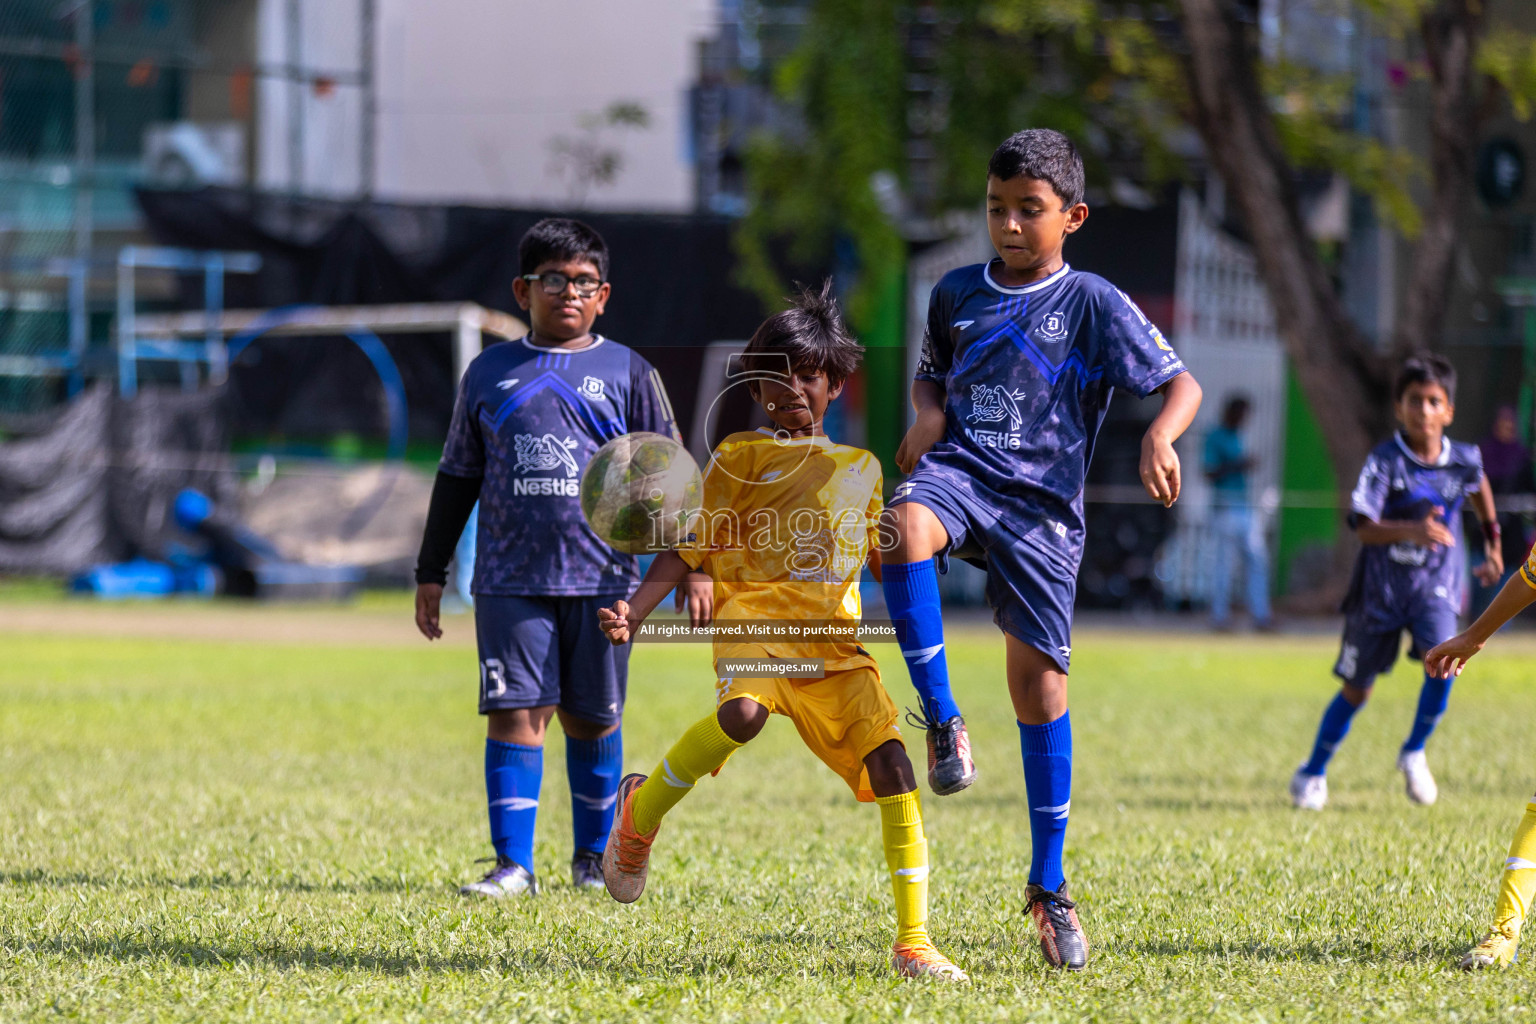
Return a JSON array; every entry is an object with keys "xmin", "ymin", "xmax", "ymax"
[{"xmin": 475, "ymin": 594, "xmax": 630, "ymax": 725}]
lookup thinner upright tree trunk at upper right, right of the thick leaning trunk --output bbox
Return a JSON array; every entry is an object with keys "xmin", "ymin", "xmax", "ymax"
[{"xmin": 1392, "ymin": 0, "xmax": 1488, "ymax": 358}]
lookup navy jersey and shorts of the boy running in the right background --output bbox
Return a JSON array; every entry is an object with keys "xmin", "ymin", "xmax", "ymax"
[{"xmin": 1344, "ymin": 434, "xmax": 1482, "ymax": 629}]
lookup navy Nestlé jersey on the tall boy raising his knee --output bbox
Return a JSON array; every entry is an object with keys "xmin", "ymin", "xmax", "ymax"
[{"xmin": 897, "ymin": 261, "xmax": 1184, "ymax": 576}]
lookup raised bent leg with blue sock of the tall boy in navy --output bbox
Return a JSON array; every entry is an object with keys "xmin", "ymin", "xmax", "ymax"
[{"xmin": 880, "ymin": 500, "xmax": 975, "ymax": 797}]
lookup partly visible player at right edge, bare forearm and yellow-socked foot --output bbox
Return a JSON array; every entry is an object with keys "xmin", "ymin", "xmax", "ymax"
[{"xmin": 1424, "ymin": 537, "xmax": 1536, "ymax": 970}]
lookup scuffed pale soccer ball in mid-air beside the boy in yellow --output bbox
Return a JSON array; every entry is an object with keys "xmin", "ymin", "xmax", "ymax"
[{"xmin": 581, "ymin": 431, "xmax": 703, "ymax": 554}]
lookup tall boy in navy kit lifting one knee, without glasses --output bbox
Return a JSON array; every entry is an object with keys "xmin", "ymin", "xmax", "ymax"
[{"xmin": 883, "ymin": 129, "xmax": 1200, "ymax": 970}]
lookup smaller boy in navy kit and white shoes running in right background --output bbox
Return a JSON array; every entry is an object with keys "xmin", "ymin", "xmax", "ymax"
[{"xmin": 1290, "ymin": 355, "xmax": 1504, "ymax": 811}]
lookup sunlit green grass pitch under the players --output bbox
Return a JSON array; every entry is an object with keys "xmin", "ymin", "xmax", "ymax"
[{"xmin": 0, "ymin": 600, "xmax": 1536, "ymax": 1022}]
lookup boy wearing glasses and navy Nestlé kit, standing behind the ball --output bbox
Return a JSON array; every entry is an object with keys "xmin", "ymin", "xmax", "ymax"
[{"xmin": 416, "ymin": 218, "xmax": 713, "ymax": 897}]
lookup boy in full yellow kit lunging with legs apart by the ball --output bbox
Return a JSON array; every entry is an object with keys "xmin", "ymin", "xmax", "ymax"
[{"xmin": 598, "ymin": 286, "xmax": 968, "ymax": 981}]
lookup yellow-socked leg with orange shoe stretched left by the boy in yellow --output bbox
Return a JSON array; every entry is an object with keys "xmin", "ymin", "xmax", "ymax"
[{"xmin": 602, "ymin": 702, "xmax": 743, "ymax": 903}]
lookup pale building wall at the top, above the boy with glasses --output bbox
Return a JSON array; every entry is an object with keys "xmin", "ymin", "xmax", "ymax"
[{"xmin": 257, "ymin": 0, "xmax": 714, "ymax": 212}]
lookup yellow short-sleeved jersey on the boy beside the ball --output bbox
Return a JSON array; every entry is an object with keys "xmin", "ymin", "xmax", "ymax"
[{"xmin": 677, "ymin": 430, "xmax": 882, "ymax": 669}]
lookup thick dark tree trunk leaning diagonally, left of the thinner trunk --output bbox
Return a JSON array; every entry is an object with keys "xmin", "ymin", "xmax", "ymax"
[{"xmin": 1180, "ymin": 0, "xmax": 1387, "ymax": 504}]
